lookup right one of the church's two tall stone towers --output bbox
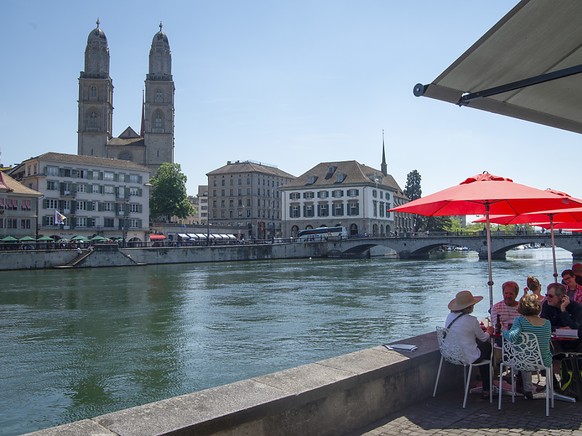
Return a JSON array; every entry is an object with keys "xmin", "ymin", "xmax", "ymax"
[{"xmin": 143, "ymin": 22, "xmax": 175, "ymax": 171}]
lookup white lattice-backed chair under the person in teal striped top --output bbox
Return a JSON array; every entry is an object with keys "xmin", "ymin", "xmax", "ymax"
[{"xmin": 498, "ymin": 332, "xmax": 554, "ymax": 416}]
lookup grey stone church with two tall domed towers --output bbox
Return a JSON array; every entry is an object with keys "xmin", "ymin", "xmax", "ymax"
[{"xmin": 77, "ymin": 20, "xmax": 175, "ymax": 174}]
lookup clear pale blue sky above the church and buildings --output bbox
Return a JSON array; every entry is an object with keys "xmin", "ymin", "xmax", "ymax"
[{"xmin": 0, "ymin": 0, "xmax": 582, "ymax": 196}]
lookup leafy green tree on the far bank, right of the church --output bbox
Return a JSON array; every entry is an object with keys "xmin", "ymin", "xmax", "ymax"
[{"xmin": 150, "ymin": 162, "xmax": 194, "ymax": 221}]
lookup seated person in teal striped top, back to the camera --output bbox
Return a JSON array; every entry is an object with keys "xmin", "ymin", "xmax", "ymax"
[{"xmin": 503, "ymin": 294, "xmax": 552, "ymax": 399}]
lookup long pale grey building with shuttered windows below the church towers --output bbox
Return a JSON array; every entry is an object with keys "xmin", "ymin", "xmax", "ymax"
[{"xmin": 10, "ymin": 153, "xmax": 150, "ymax": 241}]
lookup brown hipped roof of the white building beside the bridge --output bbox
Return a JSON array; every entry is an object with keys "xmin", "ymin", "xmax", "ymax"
[{"xmin": 282, "ymin": 160, "xmax": 402, "ymax": 193}]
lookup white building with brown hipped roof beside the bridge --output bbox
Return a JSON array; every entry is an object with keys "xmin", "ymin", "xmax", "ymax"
[{"xmin": 280, "ymin": 161, "xmax": 407, "ymax": 237}]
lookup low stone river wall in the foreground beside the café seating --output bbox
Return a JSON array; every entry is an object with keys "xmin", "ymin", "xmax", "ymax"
[{"xmin": 34, "ymin": 333, "xmax": 463, "ymax": 436}]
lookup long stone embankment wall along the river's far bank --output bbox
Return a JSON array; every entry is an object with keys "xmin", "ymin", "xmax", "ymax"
[{"xmin": 0, "ymin": 242, "xmax": 328, "ymax": 271}]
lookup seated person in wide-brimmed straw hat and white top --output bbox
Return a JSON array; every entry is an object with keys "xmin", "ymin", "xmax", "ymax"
[{"xmin": 445, "ymin": 291, "xmax": 493, "ymax": 398}]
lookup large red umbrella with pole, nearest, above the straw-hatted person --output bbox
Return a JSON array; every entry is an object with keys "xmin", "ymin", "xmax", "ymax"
[{"xmin": 390, "ymin": 172, "xmax": 582, "ymax": 312}]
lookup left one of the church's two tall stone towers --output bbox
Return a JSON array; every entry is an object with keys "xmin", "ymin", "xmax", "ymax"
[{"xmin": 77, "ymin": 19, "xmax": 113, "ymax": 157}]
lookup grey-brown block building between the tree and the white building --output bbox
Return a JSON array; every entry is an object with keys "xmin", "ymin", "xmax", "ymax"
[{"xmin": 207, "ymin": 161, "xmax": 295, "ymax": 239}]
